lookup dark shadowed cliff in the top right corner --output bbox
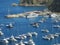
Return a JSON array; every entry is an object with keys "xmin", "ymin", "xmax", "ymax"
[{"xmin": 49, "ymin": 0, "xmax": 60, "ymax": 12}]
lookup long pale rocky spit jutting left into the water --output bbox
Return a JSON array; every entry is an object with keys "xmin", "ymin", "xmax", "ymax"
[{"xmin": 5, "ymin": 11, "xmax": 52, "ymax": 18}]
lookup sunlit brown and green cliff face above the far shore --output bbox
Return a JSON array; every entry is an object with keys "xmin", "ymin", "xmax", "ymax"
[{"xmin": 20, "ymin": 0, "xmax": 49, "ymax": 4}]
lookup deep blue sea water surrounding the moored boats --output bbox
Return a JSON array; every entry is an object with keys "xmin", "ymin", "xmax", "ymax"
[{"xmin": 0, "ymin": 0, "xmax": 60, "ymax": 45}]
